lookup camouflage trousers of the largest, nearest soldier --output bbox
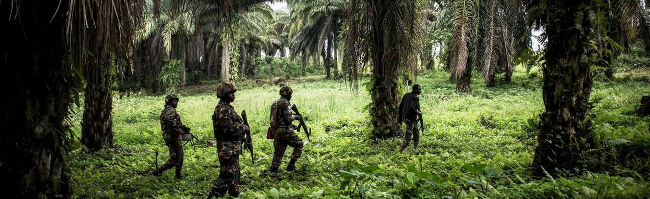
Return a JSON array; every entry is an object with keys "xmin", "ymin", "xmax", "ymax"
[{"xmin": 210, "ymin": 142, "xmax": 241, "ymax": 198}]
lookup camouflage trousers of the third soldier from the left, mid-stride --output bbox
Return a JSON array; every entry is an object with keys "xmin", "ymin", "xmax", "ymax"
[{"xmin": 269, "ymin": 127, "xmax": 303, "ymax": 171}]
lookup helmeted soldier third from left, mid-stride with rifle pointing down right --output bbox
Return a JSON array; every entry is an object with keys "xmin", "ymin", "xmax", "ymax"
[{"xmin": 269, "ymin": 86, "xmax": 304, "ymax": 173}]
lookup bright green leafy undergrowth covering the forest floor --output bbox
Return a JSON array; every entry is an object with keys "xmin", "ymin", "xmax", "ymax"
[{"xmin": 70, "ymin": 67, "xmax": 650, "ymax": 198}]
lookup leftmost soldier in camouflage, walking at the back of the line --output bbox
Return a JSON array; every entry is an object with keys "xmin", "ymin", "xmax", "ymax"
[{"xmin": 153, "ymin": 94, "xmax": 185, "ymax": 179}]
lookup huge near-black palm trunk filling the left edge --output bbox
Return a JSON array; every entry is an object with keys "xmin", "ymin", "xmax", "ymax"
[{"xmin": 0, "ymin": 0, "xmax": 73, "ymax": 198}]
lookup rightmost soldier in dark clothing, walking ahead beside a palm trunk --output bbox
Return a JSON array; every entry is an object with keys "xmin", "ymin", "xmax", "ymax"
[{"xmin": 399, "ymin": 84, "xmax": 422, "ymax": 153}]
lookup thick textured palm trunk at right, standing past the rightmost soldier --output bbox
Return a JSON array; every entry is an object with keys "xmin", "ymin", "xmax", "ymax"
[{"xmin": 533, "ymin": 0, "xmax": 594, "ymax": 176}]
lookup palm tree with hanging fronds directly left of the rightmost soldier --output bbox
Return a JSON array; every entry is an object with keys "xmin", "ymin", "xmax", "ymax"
[{"xmin": 365, "ymin": 0, "xmax": 417, "ymax": 138}]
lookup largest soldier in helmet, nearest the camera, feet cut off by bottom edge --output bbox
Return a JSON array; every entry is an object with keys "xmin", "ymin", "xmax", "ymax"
[{"xmin": 208, "ymin": 83, "xmax": 253, "ymax": 198}]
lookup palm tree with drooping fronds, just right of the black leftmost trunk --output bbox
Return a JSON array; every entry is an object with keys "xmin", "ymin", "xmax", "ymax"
[{"xmin": 76, "ymin": 0, "xmax": 143, "ymax": 152}]
